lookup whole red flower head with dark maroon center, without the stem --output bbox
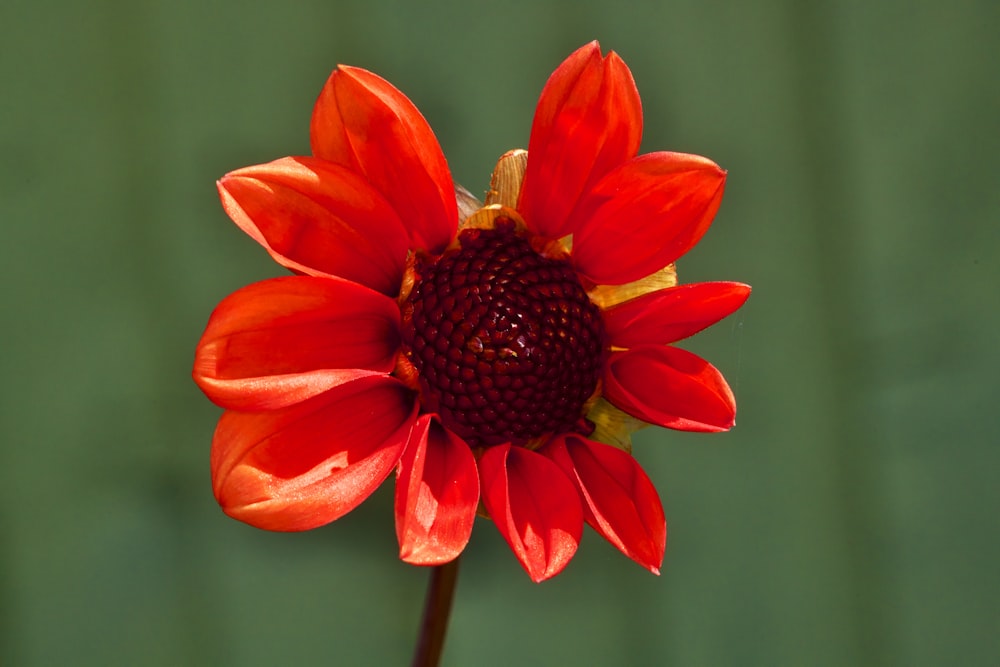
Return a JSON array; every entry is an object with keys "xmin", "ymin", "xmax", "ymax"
[{"xmin": 194, "ymin": 42, "xmax": 750, "ymax": 581}]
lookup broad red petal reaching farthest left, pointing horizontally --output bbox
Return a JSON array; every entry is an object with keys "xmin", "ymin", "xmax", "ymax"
[{"xmin": 194, "ymin": 276, "xmax": 399, "ymax": 411}]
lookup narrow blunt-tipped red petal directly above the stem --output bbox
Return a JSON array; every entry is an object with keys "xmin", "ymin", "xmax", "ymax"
[{"xmin": 396, "ymin": 415, "xmax": 479, "ymax": 565}]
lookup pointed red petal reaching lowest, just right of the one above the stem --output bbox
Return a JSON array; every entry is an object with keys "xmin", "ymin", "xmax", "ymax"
[{"xmin": 479, "ymin": 444, "xmax": 583, "ymax": 582}]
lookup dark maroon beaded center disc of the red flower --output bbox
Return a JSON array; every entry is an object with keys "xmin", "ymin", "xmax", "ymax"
[{"xmin": 403, "ymin": 224, "xmax": 604, "ymax": 446}]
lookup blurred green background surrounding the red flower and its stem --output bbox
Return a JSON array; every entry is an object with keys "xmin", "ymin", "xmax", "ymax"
[{"xmin": 0, "ymin": 0, "xmax": 1000, "ymax": 667}]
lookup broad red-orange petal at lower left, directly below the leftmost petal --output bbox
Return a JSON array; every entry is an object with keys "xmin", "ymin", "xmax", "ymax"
[{"xmin": 212, "ymin": 376, "xmax": 417, "ymax": 530}]
